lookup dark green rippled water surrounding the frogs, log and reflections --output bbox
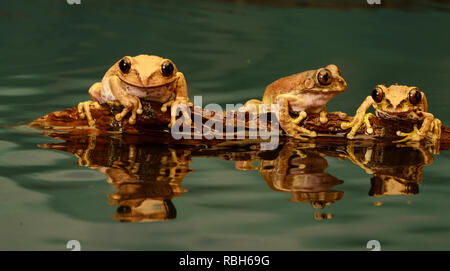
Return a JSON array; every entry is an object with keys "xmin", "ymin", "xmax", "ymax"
[{"xmin": 0, "ymin": 0, "xmax": 450, "ymax": 250}]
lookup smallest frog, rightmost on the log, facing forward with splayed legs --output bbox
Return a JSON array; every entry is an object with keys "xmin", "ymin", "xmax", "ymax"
[{"xmin": 341, "ymin": 84, "xmax": 442, "ymax": 143}]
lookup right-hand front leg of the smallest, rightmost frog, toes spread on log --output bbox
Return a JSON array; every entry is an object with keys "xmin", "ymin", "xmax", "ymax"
[{"xmin": 393, "ymin": 112, "xmax": 442, "ymax": 143}]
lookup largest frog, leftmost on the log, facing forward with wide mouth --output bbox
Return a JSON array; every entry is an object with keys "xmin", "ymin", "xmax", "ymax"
[{"xmin": 78, "ymin": 55, "xmax": 192, "ymax": 129}]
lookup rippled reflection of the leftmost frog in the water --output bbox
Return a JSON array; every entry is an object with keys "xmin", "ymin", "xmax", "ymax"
[{"xmin": 99, "ymin": 149, "xmax": 192, "ymax": 222}]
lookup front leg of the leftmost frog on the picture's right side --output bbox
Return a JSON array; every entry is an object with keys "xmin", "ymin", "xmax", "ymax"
[{"xmin": 161, "ymin": 72, "xmax": 192, "ymax": 127}]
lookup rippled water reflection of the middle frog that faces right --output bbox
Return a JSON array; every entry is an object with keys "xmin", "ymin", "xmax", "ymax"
[{"xmin": 236, "ymin": 141, "xmax": 344, "ymax": 220}]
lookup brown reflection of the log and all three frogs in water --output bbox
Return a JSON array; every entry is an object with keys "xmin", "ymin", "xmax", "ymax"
[{"xmin": 37, "ymin": 134, "xmax": 433, "ymax": 222}]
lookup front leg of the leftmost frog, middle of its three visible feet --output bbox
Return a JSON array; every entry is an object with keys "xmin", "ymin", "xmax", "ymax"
[{"xmin": 108, "ymin": 76, "xmax": 142, "ymax": 125}]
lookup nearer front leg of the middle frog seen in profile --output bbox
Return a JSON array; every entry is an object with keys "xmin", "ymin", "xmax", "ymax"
[{"xmin": 277, "ymin": 94, "xmax": 317, "ymax": 141}]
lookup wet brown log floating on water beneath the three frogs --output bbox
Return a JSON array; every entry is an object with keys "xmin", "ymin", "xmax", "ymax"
[{"xmin": 30, "ymin": 101, "xmax": 450, "ymax": 150}]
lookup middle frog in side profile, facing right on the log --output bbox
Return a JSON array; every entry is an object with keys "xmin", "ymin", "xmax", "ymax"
[{"xmin": 245, "ymin": 64, "xmax": 347, "ymax": 140}]
